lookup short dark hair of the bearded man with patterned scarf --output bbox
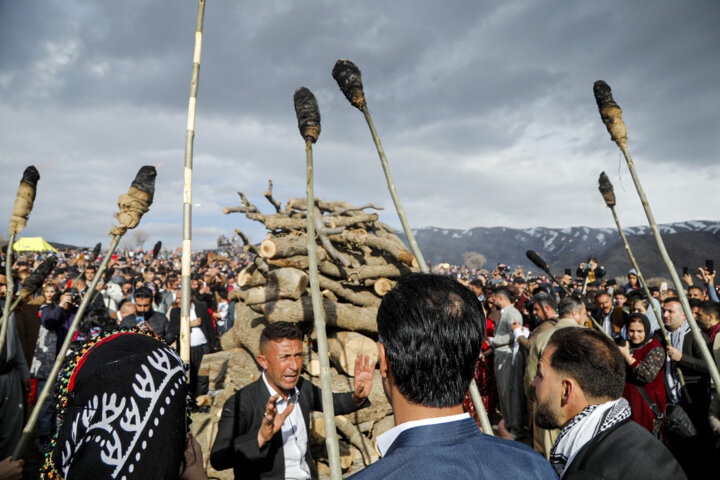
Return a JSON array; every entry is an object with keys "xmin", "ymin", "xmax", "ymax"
[{"xmin": 545, "ymin": 328, "xmax": 625, "ymax": 401}]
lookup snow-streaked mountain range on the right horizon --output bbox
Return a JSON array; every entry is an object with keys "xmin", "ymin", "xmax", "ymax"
[{"xmin": 402, "ymin": 220, "xmax": 720, "ymax": 278}]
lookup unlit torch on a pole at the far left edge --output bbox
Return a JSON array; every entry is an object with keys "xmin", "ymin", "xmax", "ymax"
[{"xmin": 0, "ymin": 165, "xmax": 40, "ymax": 352}]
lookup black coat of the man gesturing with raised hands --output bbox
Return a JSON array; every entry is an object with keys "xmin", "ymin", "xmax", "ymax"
[{"xmin": 210, "ymin": 377, "xmax": 370, "ymax": 480}]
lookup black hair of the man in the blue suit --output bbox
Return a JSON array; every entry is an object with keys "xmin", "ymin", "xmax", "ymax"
[{"xmin": 377, "ymin": 273, "xmax": 485, "ymax": 407}]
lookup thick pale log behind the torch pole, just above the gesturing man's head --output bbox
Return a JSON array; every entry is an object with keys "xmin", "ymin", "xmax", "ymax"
[{"xmin": 262, "ymin": 296, "xmax": 377, "ymax": 334}]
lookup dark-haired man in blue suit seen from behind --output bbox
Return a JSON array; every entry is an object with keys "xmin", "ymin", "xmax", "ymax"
[{"xmin": 351, "ymin": 274, "xmax": 557, "ymax": 480}]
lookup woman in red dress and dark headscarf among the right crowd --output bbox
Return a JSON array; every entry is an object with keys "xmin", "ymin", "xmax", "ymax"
[{"xmin": 620, "ymin": 313, "xmax": 667, "ymax": 438}]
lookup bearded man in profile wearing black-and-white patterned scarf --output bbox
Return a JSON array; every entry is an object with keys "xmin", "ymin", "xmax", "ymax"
[{"xmin": 533, "ymin": 328, "xmax": 687, "ymax": 480}]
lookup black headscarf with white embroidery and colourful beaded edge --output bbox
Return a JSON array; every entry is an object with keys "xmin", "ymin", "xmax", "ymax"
[{"xmin": 43, "ymin": 331, "xmax": 187, "ymax": 480}]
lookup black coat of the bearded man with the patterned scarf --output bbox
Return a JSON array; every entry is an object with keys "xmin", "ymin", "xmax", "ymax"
[{"xmin": 562, "ymin": 419, "xmax": 687, "ymax": 480}]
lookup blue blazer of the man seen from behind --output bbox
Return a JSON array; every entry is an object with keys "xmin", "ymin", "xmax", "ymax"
[{"xmin": 350, "ymin": 418, "xmax": 557, "ymax": 480}]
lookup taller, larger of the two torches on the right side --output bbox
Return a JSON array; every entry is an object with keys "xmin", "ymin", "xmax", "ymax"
[{"xmin": 593, "ymin": 80, "xmax": 720, "ymax": 392}]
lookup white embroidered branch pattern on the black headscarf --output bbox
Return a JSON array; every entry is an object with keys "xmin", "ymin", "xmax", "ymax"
[{"xmin": 62, "ymin": 347, "xmax": 185, "ymax": 480}]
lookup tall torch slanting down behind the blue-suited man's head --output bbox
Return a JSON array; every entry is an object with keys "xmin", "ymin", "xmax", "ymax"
[{"xmin": 332, "ymin": 59, "xmax": 493, "ymax": 435}]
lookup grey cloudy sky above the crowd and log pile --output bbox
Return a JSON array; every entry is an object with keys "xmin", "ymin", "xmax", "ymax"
[{"xmin": 0, "ymin": 0, "xmax": 720, "ymax": 251}]
